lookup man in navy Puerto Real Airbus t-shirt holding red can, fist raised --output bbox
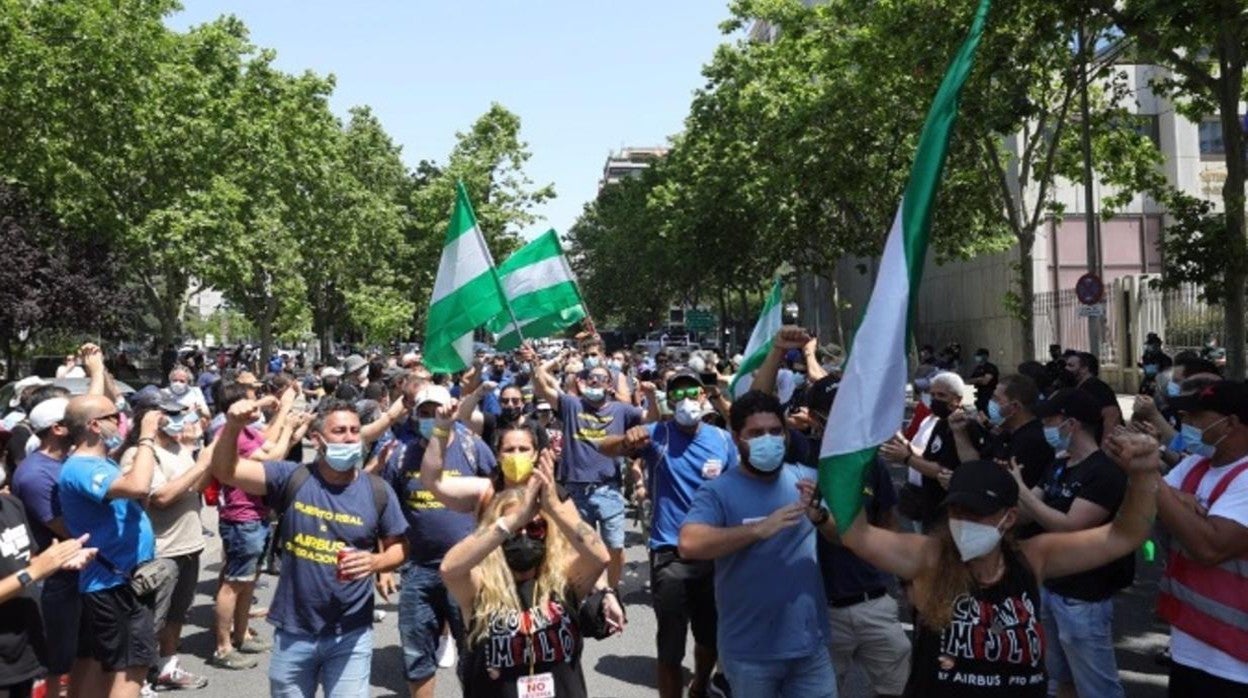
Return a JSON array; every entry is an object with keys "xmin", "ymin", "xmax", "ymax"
[{"xmin": 212, "ymin": 400, "xmax": 407, "ymax": 698}]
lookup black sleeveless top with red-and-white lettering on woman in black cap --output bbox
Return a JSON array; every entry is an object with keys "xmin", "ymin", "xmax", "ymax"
[{"xmin": 905, "ymin": 547, "xmax": 1048, "ymax": 698}]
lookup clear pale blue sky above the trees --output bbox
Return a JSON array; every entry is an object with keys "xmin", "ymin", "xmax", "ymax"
[{"xmin": 168, "ymin": 0, "xmax": 728, "ymax": 236}]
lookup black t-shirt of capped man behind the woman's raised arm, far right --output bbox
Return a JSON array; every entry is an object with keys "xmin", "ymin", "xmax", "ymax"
[{"xmin": 1028, "ymin": 451, "xmax": 1136, "ymax": 601}]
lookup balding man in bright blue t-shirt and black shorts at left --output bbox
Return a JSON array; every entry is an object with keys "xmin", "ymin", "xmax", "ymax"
[{"xmin": 57, "ymin": 395, "xmax": 162, "ymax": 698}]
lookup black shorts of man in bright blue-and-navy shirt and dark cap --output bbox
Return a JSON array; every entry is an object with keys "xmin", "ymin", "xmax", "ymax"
[{"xmin": 650, "ymin": 548, "xmax": 719, "ymax": 667}]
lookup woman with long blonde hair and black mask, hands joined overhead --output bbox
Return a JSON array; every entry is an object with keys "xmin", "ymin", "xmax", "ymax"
[{"xmin": 441, "ymin": 452, "xmax": 609, "ymax": 698}]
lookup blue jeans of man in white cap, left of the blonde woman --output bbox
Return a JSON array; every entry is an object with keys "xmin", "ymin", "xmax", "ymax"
[{"xmin": 398, "ymin": 563, "xmax": 467, "ymax": 682}]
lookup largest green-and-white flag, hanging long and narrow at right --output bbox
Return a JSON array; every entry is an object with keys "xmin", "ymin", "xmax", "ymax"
[{"xmin": 819, "ymin": 0, "xmax": 990, "ymax": 529}]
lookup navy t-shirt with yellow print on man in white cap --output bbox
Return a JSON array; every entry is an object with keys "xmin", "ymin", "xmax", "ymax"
[{"xmin": 382, "ymin": 427, "xmax": 495, "ymax": 566}]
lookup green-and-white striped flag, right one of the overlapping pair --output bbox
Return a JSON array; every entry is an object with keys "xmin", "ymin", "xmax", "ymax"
[{"xmin": 488, "ymin": 230, "xmax": 585, "ymax": 351}]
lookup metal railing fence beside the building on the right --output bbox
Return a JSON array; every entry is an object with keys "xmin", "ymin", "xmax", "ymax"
[{"xmin": 1032, "ymin": 275, "xmax": 1226, "ymax": 367}]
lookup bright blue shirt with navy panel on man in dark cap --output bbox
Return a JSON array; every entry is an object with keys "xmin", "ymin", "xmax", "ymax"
[{"xmin": 641, "ymin": 422, "xmax": 740, "ymax": 549}]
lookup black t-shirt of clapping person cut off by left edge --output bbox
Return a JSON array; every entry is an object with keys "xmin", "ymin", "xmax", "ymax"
[{"xmin": 0, "ymin": 494, "xmax": 47, "ymax": 686}]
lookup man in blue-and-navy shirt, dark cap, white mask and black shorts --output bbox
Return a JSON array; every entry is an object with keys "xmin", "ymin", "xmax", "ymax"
[{"xmin": 598, "ymin": 368, "xmax": 740, "ymax": 698}]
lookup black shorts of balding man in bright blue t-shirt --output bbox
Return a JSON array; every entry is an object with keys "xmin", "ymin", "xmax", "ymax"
[{"xmin": 79, "ymin": 584, "xmax": 157, "ymax": 672}]
